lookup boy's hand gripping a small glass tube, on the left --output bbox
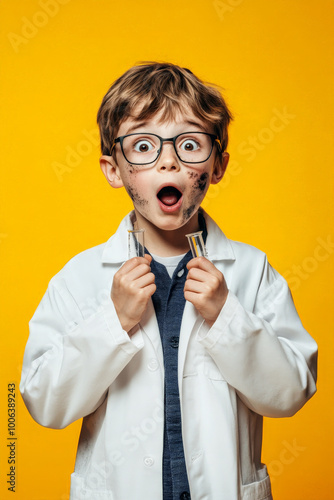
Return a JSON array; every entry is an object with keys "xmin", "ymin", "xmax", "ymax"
[{"xmin": 111, "ymin": 254, "xmax": 156, "ymax": 333}]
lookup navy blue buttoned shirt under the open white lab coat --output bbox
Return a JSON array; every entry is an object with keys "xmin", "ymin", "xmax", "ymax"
[{"xmin": 151, "ymin": 214, "xmax": 207, "ymax": 500}]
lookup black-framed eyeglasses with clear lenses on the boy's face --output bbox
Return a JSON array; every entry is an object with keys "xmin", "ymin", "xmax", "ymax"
[{"xmin": 110, "ymin": 132, "xmax": 222, "ymax": 165}]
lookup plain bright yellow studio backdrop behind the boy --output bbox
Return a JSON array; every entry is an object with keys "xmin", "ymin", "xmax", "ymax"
[{"xmin": 0, "ymin": 0, "xmax": 334, "ymax": 500}]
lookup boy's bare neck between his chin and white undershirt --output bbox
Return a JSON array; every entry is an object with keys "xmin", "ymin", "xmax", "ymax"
[{"xmin": 134, "ymin": 212, "xmax": 199, "ymax": 257}]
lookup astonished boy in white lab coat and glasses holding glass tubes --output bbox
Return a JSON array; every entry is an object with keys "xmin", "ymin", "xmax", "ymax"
[{"xmin": 20, "ymin": 63, "xmax": 317, "ymax": 500}]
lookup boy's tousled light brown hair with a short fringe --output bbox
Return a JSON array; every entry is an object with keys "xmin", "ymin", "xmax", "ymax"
[{"xmin": 97, "ymin": 62, "xmax": 232, "ymax": 155}]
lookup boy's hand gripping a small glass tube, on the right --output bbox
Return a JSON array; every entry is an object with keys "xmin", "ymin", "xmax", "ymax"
[{"xmin": 184, "ymin": 257, "xmax": 228, "ymax": 327}]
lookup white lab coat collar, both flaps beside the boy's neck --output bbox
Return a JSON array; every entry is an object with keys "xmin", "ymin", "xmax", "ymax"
[{"xmin": 102, "ymin": 209, "xmax": 235, "ymax": 264}]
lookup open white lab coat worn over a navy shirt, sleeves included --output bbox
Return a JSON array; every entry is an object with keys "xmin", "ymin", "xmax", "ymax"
[{"xmin": 20, "ymin": 214, "xmax": 317, "ymax": 500}]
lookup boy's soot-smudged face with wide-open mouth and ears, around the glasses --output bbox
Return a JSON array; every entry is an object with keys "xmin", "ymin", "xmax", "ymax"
[{"xmin": 101, "ymin": 110, "xmax": 228, "ymax": 234}]
